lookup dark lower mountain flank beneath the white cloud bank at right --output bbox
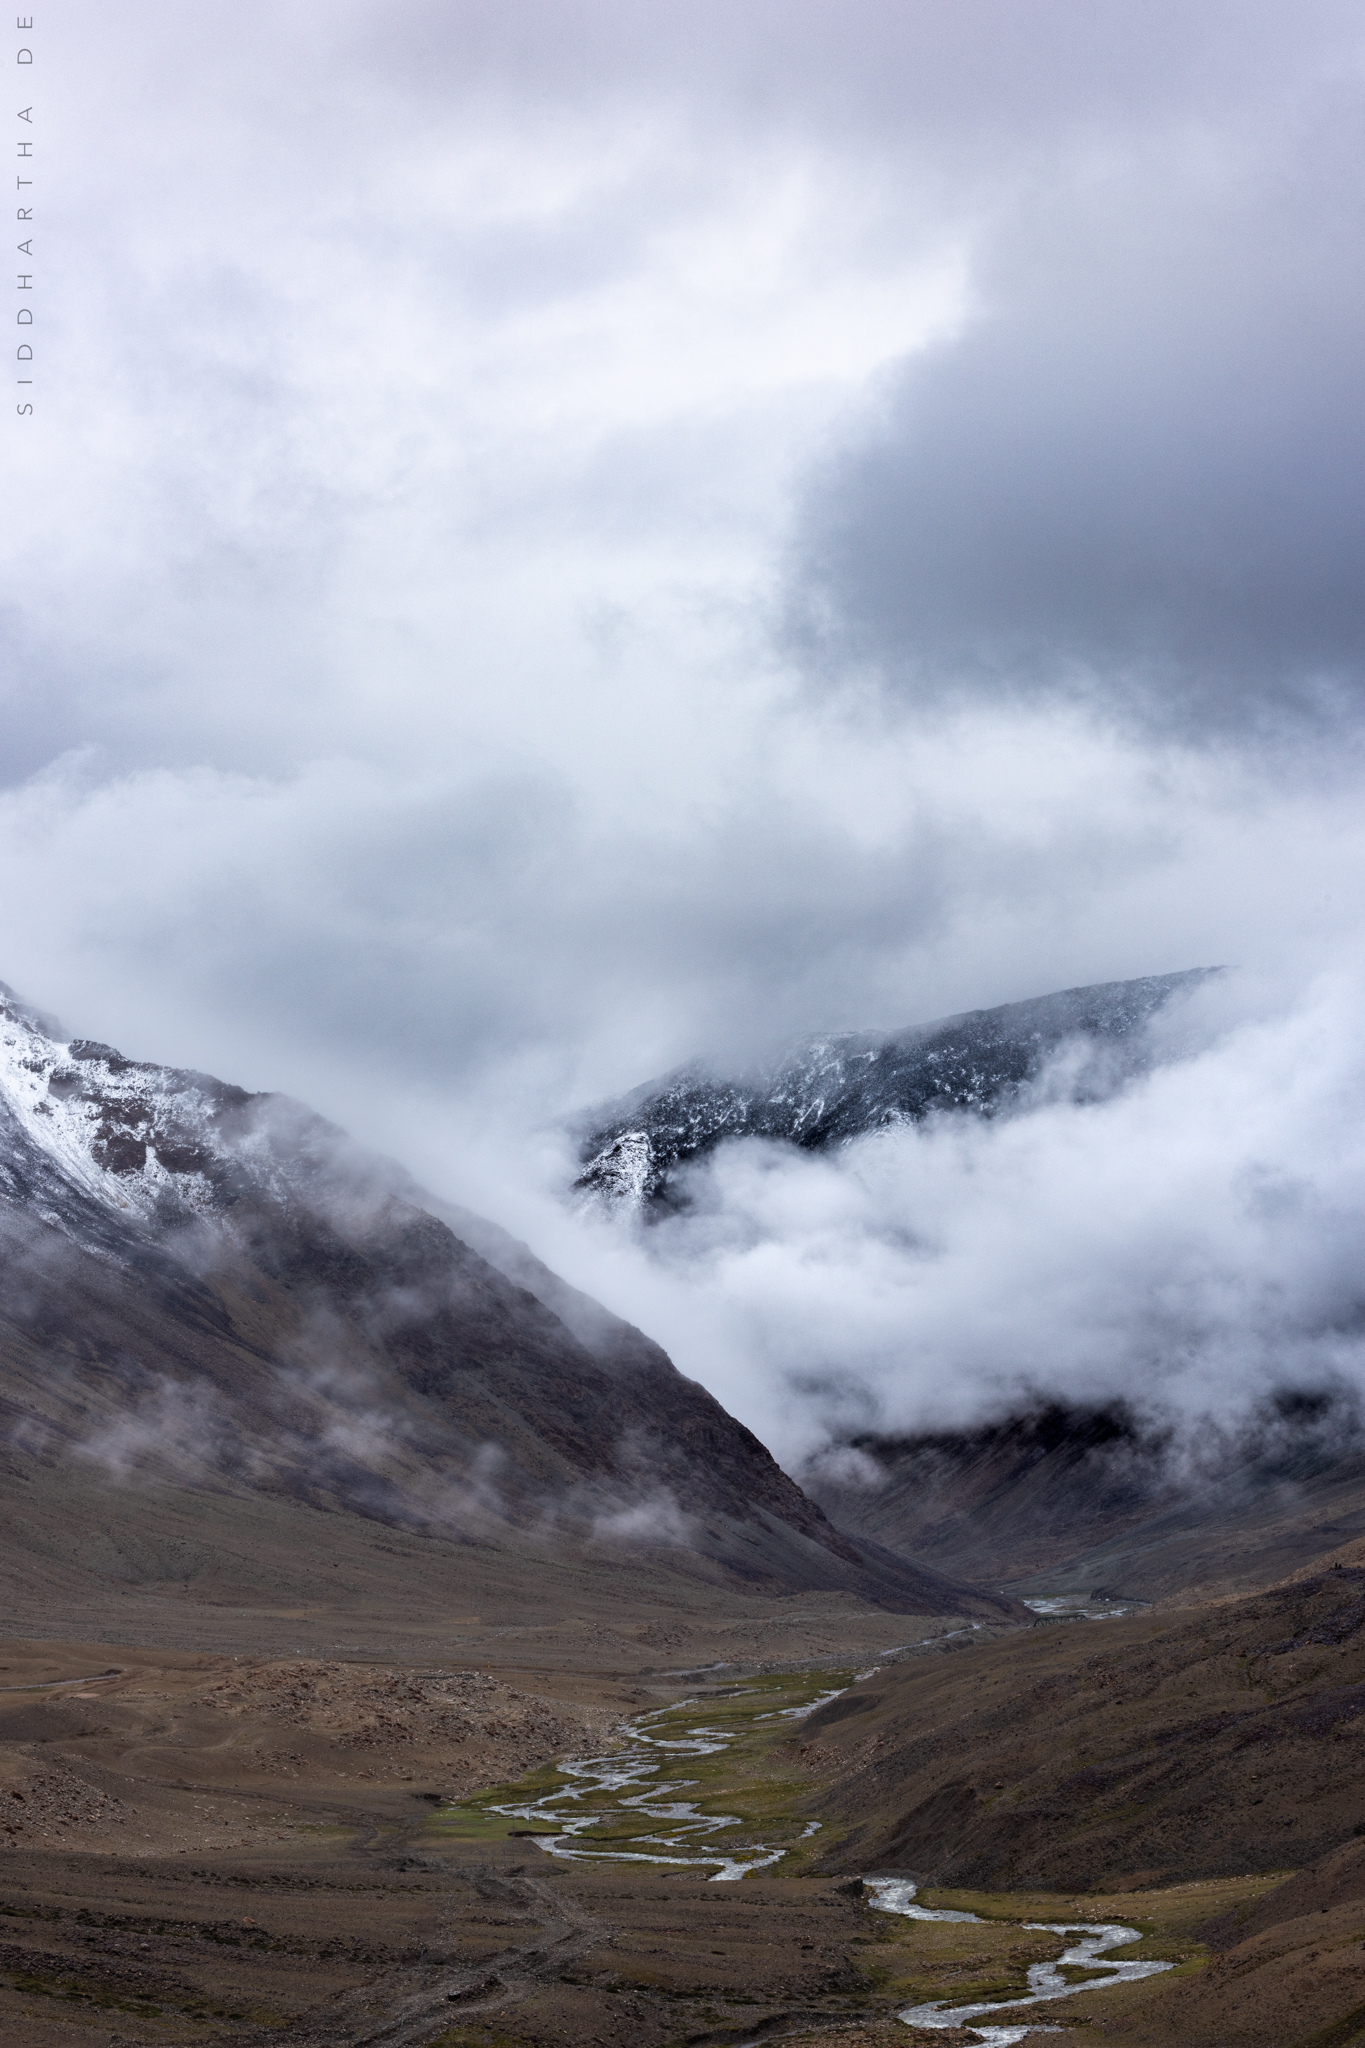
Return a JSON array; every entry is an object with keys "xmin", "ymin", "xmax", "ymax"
[{"xmin": 804, "ymin": 1393, "xmax": 1365, "ymax": 1602}]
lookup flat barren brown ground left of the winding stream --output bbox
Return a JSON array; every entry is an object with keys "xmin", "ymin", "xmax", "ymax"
[{"xmin": 0, "ymin": 1612, "xmax": 961, "ymax": 2048}]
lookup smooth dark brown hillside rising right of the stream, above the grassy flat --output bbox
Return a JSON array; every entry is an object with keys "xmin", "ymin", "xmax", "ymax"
[{"xmin": 798, "ymin": 1561, "xmax": 1365, "ymax": 1890}]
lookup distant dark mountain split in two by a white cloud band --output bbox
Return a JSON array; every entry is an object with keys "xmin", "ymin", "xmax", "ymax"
[{"xmin": 577, "ymin": 969, "xmax": 1365, "ymax": 1602}]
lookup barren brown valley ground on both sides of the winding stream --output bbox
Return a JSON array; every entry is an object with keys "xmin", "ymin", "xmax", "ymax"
[{"xmin": 0, "ymin": 1575, "xmax": 1365, "ymax": 2048}]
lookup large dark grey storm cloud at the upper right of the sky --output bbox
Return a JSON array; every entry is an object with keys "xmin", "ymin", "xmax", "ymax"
[{"xmin": 788, "ymin": 16, "xmax": 1365, "ymax": 733}]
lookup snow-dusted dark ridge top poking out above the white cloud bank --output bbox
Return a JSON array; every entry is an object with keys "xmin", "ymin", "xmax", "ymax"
[{"xmin": 575, "ymin": 967, "xmax": 1220, "ymax": 1212}]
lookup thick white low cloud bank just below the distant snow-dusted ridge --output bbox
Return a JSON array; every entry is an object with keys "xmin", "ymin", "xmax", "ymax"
[{"xmin": 527, "ymin": 971, "xmax": 1365, "ymax": 1464}]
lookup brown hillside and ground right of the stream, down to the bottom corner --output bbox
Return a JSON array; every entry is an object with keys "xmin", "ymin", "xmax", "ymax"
[{"xmin": 798, "ymin": 1544, "xmax": 1365, "ymax": 2048}]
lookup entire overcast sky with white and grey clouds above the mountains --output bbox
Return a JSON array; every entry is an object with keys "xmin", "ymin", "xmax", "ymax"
[{"xmin": 0, "ymin": 0, "xmax": 1365, "ymax": 1456}]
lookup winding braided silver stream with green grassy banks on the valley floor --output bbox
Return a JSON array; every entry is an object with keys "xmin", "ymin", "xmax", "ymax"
[{"xmin": 456, "ymin": 1677, "xmax": 1173, "ymax": 2048}]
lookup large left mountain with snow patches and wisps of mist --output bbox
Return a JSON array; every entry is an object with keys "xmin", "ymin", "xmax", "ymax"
[{"xmin": 0, "ymin": 989, "xmax": 1013, "ymax": 1614}]
